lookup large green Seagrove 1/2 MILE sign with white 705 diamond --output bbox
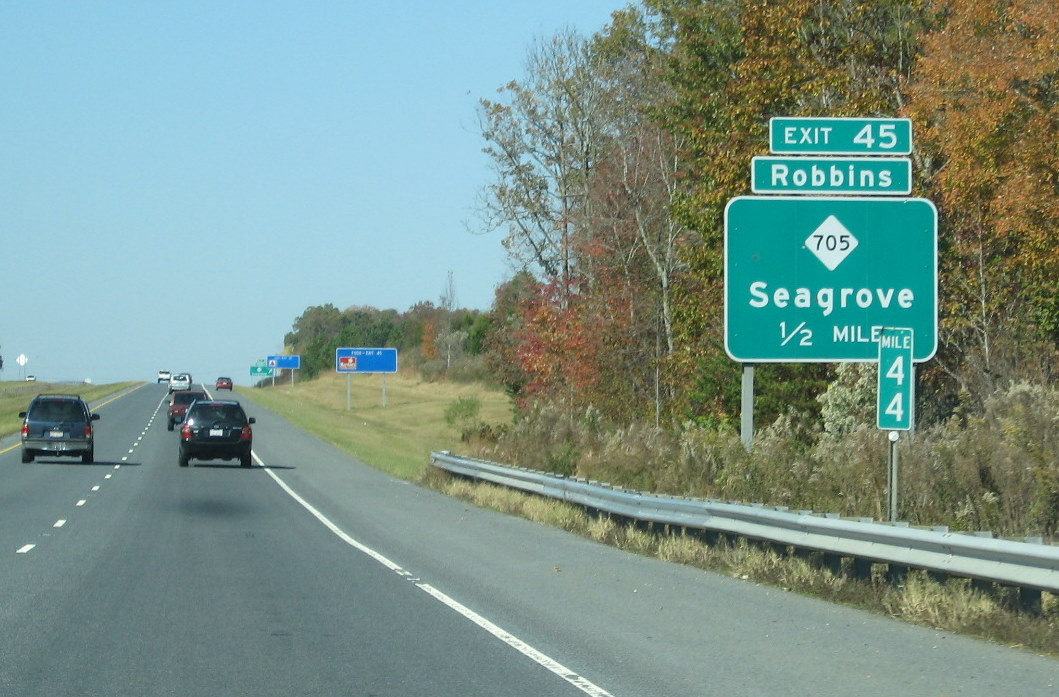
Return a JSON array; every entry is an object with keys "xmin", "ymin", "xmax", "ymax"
[{"xmin": 724, "ymin": 196, "xmax": 937, "ymax": 362}]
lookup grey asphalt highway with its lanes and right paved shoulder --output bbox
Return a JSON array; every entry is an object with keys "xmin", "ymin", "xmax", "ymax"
[{"xmin": 0, "ymin": 385, "xmax": 1059, "ymax": 697}]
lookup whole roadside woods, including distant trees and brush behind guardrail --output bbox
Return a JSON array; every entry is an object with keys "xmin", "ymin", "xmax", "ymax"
[{"xmin": 285, "ymin": 0, "xmax": 1059, "ymax": 534}]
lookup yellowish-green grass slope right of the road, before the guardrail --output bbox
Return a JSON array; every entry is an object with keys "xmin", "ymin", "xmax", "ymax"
[{"xmin": 236, "ymin": 373, "xmax": 511, "ymax": 480}]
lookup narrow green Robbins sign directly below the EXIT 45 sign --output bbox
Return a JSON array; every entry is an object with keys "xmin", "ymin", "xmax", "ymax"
[{"xmin": 750, "ymin": 157, "xmax": 912, "ymax": 196}]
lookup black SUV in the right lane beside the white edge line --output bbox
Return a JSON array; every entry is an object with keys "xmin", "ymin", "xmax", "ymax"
[{"xmin": 179, "ymin": 399, "xmax": 254, "ymax": 467}]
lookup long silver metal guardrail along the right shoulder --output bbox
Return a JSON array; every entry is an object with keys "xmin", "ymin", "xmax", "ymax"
[{"xmin": 430, "ymin": 451, "xmax": 1059, "ymax": 606}]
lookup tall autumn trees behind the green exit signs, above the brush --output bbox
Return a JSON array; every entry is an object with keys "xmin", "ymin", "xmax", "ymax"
[{"xmin": 480, "ymin": 0, "xmax": 1059, "ymax": 424}]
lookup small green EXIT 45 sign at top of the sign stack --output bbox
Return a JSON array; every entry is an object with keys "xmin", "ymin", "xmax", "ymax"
[{"xmin": 769, "ymin": 117, "xmax": 912, "ymax": 155}]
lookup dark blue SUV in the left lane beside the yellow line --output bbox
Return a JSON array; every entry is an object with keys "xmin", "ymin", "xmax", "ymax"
[{"xmin": 18, "ymin": 394, "xmax": 100, "ymax": 464}]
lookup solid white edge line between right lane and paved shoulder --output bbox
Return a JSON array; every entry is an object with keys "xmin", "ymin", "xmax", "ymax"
[{"xmin": 252, "ymin": 452, "xmax": 613, "ymax": 697}]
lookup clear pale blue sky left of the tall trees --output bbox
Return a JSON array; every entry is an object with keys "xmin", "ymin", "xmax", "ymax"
[{"xmin": 0, "ymin": 0, "xmax": 627, "ymax": 383}]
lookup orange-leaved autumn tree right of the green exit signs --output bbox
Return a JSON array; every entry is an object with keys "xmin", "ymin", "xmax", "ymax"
[{"xmin": 909, "ymin": 0, "xmax": 1059, "ymax": 400}]
